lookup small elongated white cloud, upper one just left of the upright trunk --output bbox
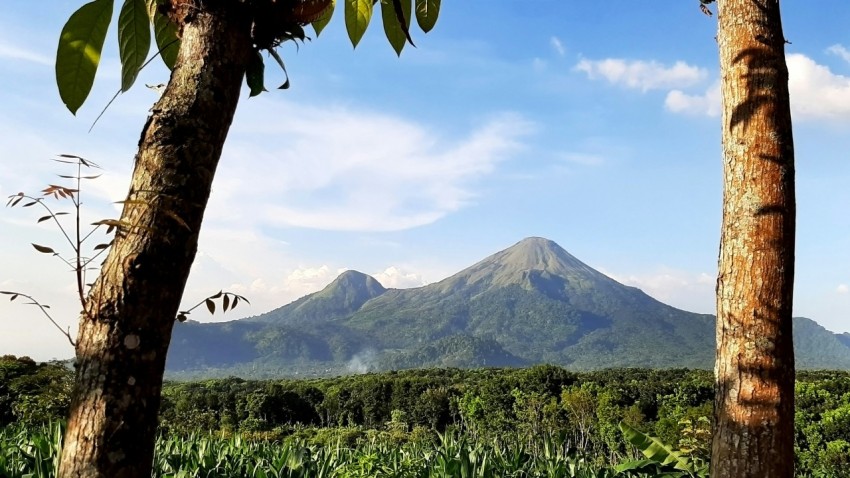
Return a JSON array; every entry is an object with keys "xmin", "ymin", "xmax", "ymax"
[{"xmin": 576, "ymin": 58, "xmax": 708, "ymax": 92}]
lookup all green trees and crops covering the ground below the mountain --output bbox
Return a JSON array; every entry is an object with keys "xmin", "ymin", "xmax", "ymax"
[{"xmin": 0, "ymin": 356, "xmax": 850, "ymax": 477}]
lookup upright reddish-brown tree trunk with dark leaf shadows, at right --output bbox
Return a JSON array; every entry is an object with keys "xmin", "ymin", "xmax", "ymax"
[{"xmin": 711, "ymin": 0, "xmax": 796, "ymax": 478}]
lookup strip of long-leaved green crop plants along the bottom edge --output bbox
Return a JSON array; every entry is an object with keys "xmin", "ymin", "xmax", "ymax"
[{"xmin": 0, "ymin": 424, "xmax": 692, "ymax": 478}]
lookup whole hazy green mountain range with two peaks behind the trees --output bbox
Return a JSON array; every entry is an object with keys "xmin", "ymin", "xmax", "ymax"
[{"xmin": 167, "ymin": 237, "xmax": 850, "ymax": 376}]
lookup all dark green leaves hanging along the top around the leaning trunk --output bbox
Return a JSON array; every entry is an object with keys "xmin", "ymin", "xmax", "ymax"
[{"xmin": 56, "ymin": 0, "xmax": 440, "ymax": 110}]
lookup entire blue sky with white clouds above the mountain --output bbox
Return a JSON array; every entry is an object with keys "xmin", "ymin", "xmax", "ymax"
[{"xmin": 0, "ymin": 0, "xmax": 850, "ymax": 359}]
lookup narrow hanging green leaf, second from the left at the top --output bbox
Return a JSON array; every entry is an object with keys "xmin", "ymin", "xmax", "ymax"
[{"xmin": 118, "ymin": 0, "xmax": 151, "ymax": 91}]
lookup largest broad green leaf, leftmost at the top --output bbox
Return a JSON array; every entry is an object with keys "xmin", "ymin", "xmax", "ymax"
[{"xmin": 56, "ymin": 0, "xmax": 113, "ymax": 114}]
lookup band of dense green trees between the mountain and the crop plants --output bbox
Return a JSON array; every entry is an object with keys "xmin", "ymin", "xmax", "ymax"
[{"xmin": 0, "ymin": 356, "xmax": 850, "ymax": 477}]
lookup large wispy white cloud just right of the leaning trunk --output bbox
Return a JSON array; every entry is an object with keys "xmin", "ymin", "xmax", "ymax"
[{"xmin": 208, "ymin": 101, "xmax": 532, "ymax": 231}]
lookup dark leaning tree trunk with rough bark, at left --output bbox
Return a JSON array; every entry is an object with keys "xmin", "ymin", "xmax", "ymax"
[{"xmin": 59, "ymin": 0, "xmax": 252, "ymax": 478}]
